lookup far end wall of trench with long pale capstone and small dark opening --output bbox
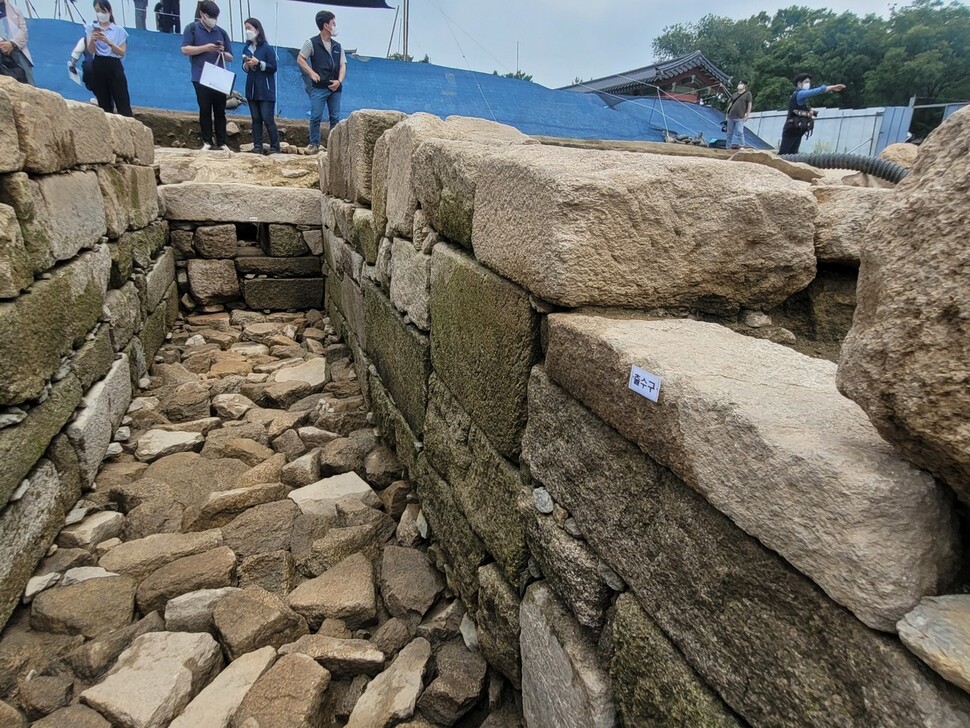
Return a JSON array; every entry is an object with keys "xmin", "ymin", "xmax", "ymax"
[{"xmin": 159, "ymin": 182, "xmax": 323, "ymax": 312}]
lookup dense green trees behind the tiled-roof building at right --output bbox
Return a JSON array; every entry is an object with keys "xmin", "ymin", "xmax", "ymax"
[{"xmin": 653, "ymin": 0, "xmax": 970, "ymax": 111}]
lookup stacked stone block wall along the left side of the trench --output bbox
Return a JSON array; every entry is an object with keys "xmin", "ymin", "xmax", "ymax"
[{"xmin": 0, "ymin": 78, "xmax": 172, "ymax": 625}]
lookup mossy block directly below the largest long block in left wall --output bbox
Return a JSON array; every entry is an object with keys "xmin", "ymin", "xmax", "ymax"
[{"xmin": 0, "ymin": 374, "xmax": 83, "ymax": 510}]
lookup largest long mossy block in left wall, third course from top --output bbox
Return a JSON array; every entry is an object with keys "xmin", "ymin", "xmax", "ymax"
[{"xmin": 0, "ymin": 245, "xmax": 111, "ymax": 405}]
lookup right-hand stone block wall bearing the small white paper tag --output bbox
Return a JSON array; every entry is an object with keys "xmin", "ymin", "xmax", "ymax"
[{"xmin": 321, "ymin": 112, "xmax": 970, "ymax": 728}]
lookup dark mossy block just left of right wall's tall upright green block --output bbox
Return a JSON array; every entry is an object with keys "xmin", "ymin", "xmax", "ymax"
[{"xmin": 364, "ymin": 277, "xmax": 431, "ymax": 435}]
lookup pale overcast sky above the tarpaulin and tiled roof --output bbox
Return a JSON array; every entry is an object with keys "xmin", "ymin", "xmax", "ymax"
[{"xmin": 26, "ymin": 0, "xmax": 905, "ymax": 88}]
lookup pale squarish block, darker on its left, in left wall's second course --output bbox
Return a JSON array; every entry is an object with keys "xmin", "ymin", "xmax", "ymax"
[{"xmin": 0, "ymin": 172, "xmax": 107, "ymax": 273}]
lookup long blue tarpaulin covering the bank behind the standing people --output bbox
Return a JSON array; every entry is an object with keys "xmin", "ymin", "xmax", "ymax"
[{"xmin": 28, "ymin": 19, "xmax": 768, "ymax": 148}]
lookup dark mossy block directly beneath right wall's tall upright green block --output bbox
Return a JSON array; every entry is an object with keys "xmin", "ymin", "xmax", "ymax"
[{"xmin": 424, "ymin": 375, "xmax": 528, "ymax": 584}]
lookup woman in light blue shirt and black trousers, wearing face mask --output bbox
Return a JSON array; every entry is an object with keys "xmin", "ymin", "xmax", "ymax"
[{"xmin": 87, "ymin": 0, "xmax": 132, "ymax": 116}]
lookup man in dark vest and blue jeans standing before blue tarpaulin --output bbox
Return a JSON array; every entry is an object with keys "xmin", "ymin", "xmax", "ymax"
[{"xmin": 296, "ymin": 10, "xmax": 347, "ymax": 153}]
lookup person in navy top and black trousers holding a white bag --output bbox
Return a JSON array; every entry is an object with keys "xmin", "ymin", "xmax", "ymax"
[{"xmin": 182, "ymin": 0, "xmax": 232, "ymax": 152}]
